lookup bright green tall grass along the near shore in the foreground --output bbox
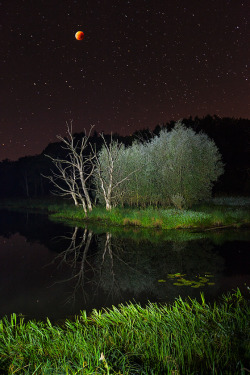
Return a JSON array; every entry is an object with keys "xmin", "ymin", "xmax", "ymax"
[{"xmin": 0, "ymin": 290, "xmax": 250, "ymax": 375}]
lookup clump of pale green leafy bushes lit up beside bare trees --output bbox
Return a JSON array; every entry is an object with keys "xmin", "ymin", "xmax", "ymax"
[{"xmin": 98, "ymin": 123, "xmax": 223, "ymax": 209}]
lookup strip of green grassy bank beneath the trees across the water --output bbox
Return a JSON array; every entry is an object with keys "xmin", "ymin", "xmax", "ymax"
[{"xmin": 0, "ymin": 197, "xmax": 250, "ymax": 230}]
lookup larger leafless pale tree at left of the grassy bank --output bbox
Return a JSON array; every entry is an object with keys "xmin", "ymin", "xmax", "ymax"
[{"xmin": 45, "ymin": 122, "xmax": 94, "ymax": 216}]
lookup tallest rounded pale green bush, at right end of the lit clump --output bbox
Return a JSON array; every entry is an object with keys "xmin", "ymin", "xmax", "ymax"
[{"xmin": 148, "ymin": 123, "xmax": 223, "ymax": 208}]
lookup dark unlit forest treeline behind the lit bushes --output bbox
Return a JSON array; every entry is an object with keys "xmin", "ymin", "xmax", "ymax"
[{"xmin": 0, "ymin": 115, "xmax": 250, "ymax": 200}]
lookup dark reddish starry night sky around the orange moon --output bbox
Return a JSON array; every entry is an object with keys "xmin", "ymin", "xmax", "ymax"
[{"xmin": 0, "ymin": 0, "xmax": 250, "ymax": 160}]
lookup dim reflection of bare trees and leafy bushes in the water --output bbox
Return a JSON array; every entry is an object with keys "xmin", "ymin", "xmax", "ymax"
[{"xmin": 48, "ymin": 227, "xmax": 229, "ymax": 304}]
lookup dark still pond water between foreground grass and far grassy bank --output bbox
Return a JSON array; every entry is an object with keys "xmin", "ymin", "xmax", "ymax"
[{"xmin": 0, "ymin": 211, "xmax": 250, "ymax": 320}]
